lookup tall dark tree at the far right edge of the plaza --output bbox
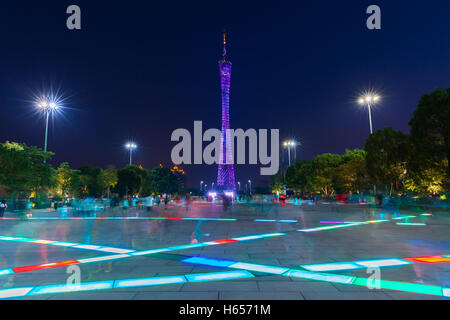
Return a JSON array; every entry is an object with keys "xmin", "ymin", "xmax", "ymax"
[{"xmin": 408, "ymin": 89, "xmax": 450, "ymax": 190}]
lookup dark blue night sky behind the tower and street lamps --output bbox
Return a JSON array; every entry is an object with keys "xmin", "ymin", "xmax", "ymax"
[{"xmin": 0, "ymin": 0, "xmax": 450, "ymax": 187}]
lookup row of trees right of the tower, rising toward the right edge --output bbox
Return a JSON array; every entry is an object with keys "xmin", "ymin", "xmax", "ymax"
[{"xmin": 271, "ymin": 89, "xmax": 450, "ymax": 196}]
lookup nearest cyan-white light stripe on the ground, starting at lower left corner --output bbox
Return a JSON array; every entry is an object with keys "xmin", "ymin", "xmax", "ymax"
[{"xmin": 0, "ymin": 271, "xmax": 254, "ymax": 299}]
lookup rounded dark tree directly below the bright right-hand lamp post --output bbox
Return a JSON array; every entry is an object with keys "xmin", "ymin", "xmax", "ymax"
[{"xmin": 364, "ymin": 127, "xmax": 411, "ymax": 194}]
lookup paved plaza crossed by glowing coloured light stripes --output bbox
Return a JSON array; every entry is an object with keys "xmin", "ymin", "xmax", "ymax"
[{"xmin": 0, "ymin": 201, "xmax": 450, "ymax": 300}]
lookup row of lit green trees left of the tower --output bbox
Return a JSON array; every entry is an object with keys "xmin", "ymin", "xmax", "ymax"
[{"xmin": 0, "ymin": 141, "xmax": 180, "ymax": 200}]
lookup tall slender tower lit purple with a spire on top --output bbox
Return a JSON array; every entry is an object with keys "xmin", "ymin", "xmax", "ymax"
[{"xmin": 217, "ymin": 33, "xmax": 235, "ymax": 191}]
